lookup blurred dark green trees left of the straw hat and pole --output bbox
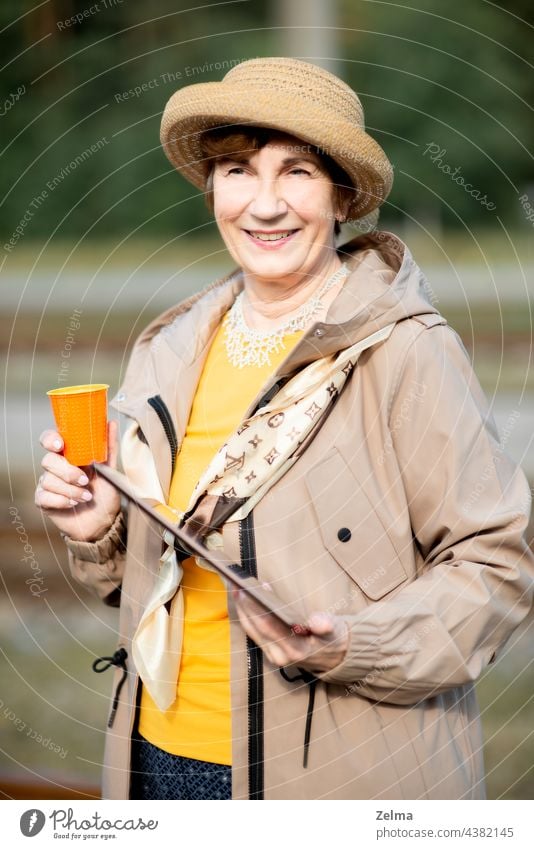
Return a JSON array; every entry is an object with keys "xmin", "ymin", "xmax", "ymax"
[{"xmin": 0, "ymin": 0, "xmax": 272, "ymax": 242}]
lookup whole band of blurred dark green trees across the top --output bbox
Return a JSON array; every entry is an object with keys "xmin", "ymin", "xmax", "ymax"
[{"xmin": 0, "ymin": 0, "xmax": 534, "ymax": 244}]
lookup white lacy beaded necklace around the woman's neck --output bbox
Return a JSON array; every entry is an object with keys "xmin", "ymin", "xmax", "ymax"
[{"xmin": 224, "ymin": 263, "xmax": 350, "ymax": 368}]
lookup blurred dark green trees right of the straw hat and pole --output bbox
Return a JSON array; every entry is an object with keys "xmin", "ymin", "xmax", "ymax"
[{"xmin": 340, "ymin": 0, "xmax": 534, "ymax": 227}]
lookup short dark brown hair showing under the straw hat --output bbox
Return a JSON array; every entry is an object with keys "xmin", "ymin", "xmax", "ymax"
[{"xmin": 200, "ymin": 125, "xmax": 356, "ymax": 236}]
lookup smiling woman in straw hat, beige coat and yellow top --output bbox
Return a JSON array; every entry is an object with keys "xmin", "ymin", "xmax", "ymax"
[{"xmin": 36, "ymin": 57, "xmax": 534, "ymax": 799}]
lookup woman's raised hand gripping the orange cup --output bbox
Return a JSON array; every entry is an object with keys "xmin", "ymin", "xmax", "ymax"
[{"xmin": 35, "ymin": 422, "xmax": 120, "ymax": 542}]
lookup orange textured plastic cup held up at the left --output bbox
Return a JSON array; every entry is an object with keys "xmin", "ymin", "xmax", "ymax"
[{"xmin": 46, "ymin": 383, "xmax": 109, "ymax": 466}]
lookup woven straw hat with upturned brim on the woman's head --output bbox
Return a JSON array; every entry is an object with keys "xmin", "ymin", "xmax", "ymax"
[{"xmin": 160, "ymin": 57, "xmax": 393, "ymax": 220}]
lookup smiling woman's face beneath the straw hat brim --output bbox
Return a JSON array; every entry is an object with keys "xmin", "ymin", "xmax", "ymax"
[{"xmin": 213, "ymin": 135, "xmax": 342, "ymax": 281}]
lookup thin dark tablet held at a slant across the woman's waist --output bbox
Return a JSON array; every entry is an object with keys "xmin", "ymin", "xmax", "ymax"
[{"xmin": 93, "ymin": 463, "xmax": 310, "ymax": 635}]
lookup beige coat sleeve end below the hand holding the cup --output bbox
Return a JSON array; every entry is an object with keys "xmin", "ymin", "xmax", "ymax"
[{"xmin": 62, "ymin": 511, "xmax": 126, "ymax": 607}]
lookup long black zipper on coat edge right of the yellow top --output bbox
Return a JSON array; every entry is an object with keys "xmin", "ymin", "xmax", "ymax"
[{"xmin": 239, "ymin": 513, "xmax": 264, "ymax": 799}]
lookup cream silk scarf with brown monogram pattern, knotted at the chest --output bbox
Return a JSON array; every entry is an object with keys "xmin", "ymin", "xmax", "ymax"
[{"xmin": 132, "ymin": 323, "xmax": 395, "ymax": 710}]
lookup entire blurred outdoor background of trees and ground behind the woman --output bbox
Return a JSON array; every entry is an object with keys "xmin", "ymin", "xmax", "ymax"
[{"xmin": 0, "ymin": 0, "xmax": 534, "ymax": 799}]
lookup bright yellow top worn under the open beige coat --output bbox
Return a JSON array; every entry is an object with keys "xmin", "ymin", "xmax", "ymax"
[{"xmin": 139, "ymin": 321, "xmax": 302, "ymax": 764}]
